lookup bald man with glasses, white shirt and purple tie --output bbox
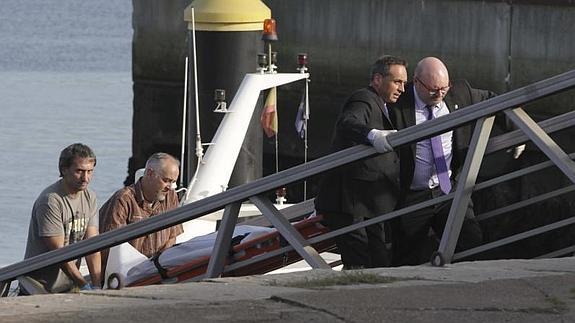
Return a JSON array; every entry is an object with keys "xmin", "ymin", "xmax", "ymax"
[{"xmin": 391, "ymin": 57, "xmax": 488, "ymax": 265}]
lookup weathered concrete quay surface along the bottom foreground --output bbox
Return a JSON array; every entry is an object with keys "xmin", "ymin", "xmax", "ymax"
[{"xmin": 0, "ymin": 258, "xmax": 575, "ymax": 323}]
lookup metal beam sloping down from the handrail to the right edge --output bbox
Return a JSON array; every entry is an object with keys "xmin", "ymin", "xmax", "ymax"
[{"xmin": 505, "ymin": 108, "xmax": 575, "ymax": 184}]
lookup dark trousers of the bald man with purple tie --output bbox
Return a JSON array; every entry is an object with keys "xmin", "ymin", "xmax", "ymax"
[{"xmin": 392, "ymin": 188, "xmax": 483, "ymax": 266}]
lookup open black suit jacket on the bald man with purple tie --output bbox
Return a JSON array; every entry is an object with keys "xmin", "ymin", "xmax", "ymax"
[{"xmin": 388, "ymin": 80, "xmax": 496, "ymax": 194}]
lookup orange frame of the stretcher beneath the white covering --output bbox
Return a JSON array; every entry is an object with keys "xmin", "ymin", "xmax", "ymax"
[{"xmin": 127, "ymin": 216, "xmax": 336, "ymax": 287}]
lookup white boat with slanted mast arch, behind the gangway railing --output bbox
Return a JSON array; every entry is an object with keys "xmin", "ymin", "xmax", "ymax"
[{"xmin": 105, "ymin": 73, "xmax": 339, "ymax": 288}]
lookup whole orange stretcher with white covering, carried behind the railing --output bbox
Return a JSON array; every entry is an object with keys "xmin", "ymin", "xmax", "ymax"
[{"xmin": 106, "ymin": 216, "xmax": 335, "ymax": 288}]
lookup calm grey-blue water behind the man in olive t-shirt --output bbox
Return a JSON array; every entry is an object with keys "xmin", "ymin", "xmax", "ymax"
[{"xmin": 0, "ymin": 0, "xmax": 132, "ymax": 265}]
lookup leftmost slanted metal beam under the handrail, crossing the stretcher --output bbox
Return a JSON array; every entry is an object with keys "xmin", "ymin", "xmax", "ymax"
[{"xmin": 206, "ymin": 202, "xmax": 242, "ymax": 278}]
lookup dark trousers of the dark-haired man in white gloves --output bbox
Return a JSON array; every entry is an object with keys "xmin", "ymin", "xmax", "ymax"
[{"xmin": 323, "ymin": 213, "xmax": 391, "ymax": 269}]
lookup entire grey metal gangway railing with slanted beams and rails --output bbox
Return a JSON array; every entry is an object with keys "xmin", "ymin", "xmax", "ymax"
[{"xmin": 0, "ymin": 70, "xmax": 575, "ymax": 294}]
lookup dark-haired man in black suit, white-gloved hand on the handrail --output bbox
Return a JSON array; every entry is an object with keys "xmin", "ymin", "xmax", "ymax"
[{"xmin": 315, "ymin": 56, "xmax": 407, "ymax": 269}]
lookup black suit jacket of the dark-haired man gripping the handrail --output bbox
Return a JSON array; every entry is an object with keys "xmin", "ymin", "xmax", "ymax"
[{"xmin": 315, "ymin": 87, "xmax": 399, "ymax": 217}]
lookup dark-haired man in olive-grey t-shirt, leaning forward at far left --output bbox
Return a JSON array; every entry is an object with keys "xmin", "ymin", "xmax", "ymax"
[{"xmin": 19, "ymin": 144, "xmax": 101, "ymax": 294}]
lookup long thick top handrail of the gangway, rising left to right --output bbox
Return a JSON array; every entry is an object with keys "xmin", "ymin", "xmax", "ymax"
[{"xmin": 0, "ymin": 70, "xmax": 575, "ymax": 282}]
